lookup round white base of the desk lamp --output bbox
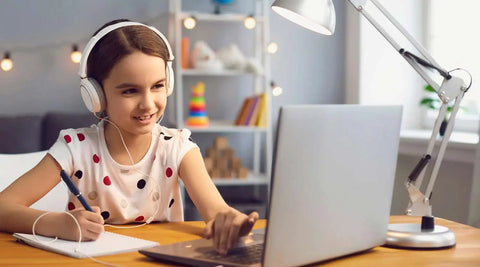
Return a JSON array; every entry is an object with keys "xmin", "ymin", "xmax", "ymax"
[{"xmin": 385, "ymin": 223, "xmax": 456, "ymax": 249}]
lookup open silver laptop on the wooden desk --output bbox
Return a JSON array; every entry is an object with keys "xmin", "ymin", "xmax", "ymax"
[{"xmin": 140, "ymin": 105, "xmax": 402, "ymax": 267}]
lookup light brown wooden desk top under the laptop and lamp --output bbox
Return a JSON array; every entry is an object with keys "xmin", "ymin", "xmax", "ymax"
[{"xmin": 0, "ymin": 216, "xmax": 480, "ymax": 267}]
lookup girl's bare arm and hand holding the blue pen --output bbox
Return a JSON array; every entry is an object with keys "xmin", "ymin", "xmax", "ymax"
[{"xmin": 0, "ymin": 154, "xmax": 103, "ymax": 240}]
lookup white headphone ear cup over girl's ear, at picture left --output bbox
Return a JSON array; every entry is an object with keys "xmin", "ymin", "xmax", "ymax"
[{"xmin": 80, "ymin": 77, "xmax": 105, "ymax": 113}]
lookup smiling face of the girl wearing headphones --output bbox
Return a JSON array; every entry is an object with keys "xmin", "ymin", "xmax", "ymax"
[{"xmin": 103, "ymin": 51, "xmax": 167, "ymax": 138}]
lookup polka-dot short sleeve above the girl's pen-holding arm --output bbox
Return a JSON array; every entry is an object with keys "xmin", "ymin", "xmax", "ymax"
[{"xmin": 48, "ymin": 129, "xmax": 73, "ymax": 174}]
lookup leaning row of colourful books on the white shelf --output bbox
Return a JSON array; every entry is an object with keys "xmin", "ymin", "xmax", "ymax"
[{"xmin": 234, "ymin": 93, "xmax": 266, "ymax": 127}]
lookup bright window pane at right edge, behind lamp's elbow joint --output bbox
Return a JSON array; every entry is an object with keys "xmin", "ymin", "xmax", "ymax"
[{"xmin": 425, "ymin": 0, "xmax": 480, "ymax": 130}]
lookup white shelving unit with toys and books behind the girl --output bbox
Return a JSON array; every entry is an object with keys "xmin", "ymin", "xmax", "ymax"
[{"xmin": 168, "ymin": 0, "xmax": 273, "ymax": 186}]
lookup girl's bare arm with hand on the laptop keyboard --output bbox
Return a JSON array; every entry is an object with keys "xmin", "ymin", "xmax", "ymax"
[{"xmin": 179, "ymin": 148, "xmax": 258, "ymax": 254}]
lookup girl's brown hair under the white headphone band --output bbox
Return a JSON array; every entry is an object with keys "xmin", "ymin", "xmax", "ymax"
[{"xmin": 87, "ymin": 19, "xmax": 169, "ymax": 88}]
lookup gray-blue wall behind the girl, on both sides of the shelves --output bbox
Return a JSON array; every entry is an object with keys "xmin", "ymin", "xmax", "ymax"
[{"xmin": 0, "ymin": 0, "xmax": 344, "ymax": 118}]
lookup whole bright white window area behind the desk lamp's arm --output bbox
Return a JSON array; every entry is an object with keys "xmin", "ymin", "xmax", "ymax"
[{"xmin": 346, "ymin": 0, "xmax": 480, "ymax": 134}]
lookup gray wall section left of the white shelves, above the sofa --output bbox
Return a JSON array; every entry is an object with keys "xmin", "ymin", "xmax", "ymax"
[{"xmin": 0, "ymin": 0, "xmax": 167, "ymax": 115}]
